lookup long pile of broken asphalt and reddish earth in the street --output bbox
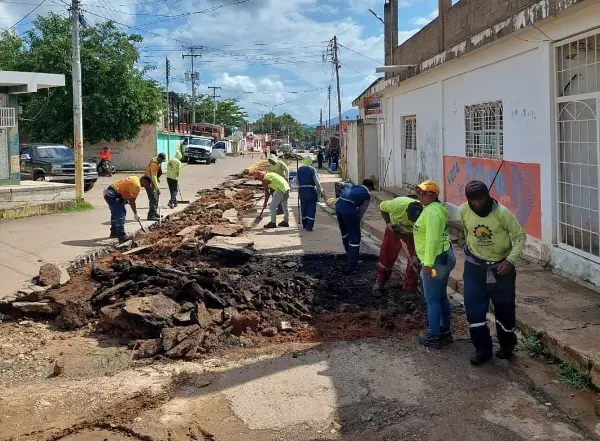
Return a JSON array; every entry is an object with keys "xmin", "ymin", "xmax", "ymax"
[{"xmin": 4, "ymin": 174, "xmax": 424, "ymax": 359}]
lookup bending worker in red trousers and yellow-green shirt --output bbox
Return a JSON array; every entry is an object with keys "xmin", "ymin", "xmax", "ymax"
[{"xmin": 373, "ymin": 196, "xmax": 423, "ymax": 293}]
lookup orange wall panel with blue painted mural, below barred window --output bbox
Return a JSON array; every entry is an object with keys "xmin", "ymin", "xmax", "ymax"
[{"xmin": 444, "ymin": 156, "xmax": 542, "ymax": 239}]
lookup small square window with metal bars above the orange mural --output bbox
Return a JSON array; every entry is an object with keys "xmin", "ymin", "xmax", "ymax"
[{"xmin": 465, "ymin": 101, "xmax": 504, "ymax": 159}]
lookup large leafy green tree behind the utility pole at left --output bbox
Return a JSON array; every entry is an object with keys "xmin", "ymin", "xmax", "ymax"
[{"xmin": 0, "ymin": 13, "xmax": 163, "ymax": 143}]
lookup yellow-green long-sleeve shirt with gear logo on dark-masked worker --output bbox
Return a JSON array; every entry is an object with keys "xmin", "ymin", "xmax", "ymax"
[{"xmin": 460, "ymin": 202, "xmax": 527, "ymax": 265}]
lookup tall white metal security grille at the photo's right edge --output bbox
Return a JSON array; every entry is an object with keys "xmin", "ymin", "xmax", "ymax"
[{"xmin": 555, "ymin": 30, "xmax": 600, "ymax": 262}]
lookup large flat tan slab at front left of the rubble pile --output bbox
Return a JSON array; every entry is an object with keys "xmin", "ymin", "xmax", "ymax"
[{"xmin": 123, "ymin": 294, "xmax": 180, "ymax": 328}]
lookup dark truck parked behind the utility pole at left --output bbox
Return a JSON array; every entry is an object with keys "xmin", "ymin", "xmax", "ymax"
[{"xmin": 20, "ymin": 144, "xmax": 98, "ymax": 191}]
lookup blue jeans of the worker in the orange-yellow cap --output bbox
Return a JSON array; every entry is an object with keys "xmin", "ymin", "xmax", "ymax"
[{"xmin": 421, "ymin": 247, "xmax": 456, "ymax": 335}]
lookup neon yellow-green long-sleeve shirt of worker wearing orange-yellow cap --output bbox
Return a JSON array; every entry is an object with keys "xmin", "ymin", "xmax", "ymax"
[{"xmin": 414, "ymin": 202, "xmax": 450, "ymax": 267}]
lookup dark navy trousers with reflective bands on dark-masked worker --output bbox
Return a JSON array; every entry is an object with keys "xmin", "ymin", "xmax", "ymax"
[{"xmin": 463, "ymin": 261, "xmax": 517, "ymax": 354}]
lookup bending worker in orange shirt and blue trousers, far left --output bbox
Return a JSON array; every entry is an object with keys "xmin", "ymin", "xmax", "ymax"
[{"xmin": 104, "ymin": 175, "xmax": 152, "ymax": 243}]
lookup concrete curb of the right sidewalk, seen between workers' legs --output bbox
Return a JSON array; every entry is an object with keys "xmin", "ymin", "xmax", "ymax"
[{"xmin": 320, "ymin": 194, "xmax": 600, "ymax": 388}]
